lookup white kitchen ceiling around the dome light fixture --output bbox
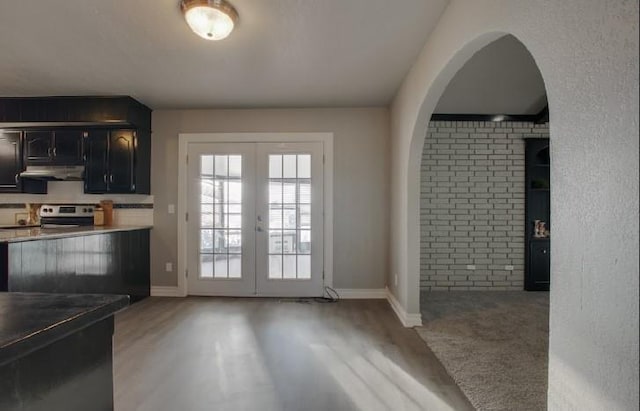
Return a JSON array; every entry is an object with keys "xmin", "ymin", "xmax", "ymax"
[{"xmin": 0, "ymin": 0, "xmax": 448, "ymax": 109}]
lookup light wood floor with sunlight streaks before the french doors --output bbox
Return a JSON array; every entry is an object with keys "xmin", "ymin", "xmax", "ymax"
[{"xmin": 114, "ymin": 297, "xmax": 473, "ymax": 411}]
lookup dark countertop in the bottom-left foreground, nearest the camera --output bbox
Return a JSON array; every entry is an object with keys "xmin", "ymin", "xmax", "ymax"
[{"xmin": 0, "ymin": 292, "xmax": 129, "ymax": 365}]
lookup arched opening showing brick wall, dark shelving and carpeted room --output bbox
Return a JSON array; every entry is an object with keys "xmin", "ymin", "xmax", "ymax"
[{"xmin": 408, "ymin": 35, "xmax": 551, "ymax": 409}]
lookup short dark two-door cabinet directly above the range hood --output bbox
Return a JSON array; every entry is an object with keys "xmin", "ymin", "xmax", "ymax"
[{"xmin": 24, "ymin": 129, "xmax": 85, "ymax": 166}]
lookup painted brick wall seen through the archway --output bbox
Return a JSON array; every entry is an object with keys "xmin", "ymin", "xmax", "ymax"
[{"xmin": 420, "ymin": 121, "xmax": 549, "ymax": 290}]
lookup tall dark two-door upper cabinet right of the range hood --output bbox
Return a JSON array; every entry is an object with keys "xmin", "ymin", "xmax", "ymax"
[{"xmin": 84, "ymin": 130, "xmax": 137, "ymax": 193}]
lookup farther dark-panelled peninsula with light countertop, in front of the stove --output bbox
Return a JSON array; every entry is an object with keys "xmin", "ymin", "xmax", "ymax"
[{"xmin": 0, "ymin": 226, "xmax": 151, "ymax": 301}]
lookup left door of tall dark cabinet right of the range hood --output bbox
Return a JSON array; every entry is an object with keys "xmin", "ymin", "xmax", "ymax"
[{"xmin": 84, "ymin": 130, "xmax": 109, "ymax": 193}]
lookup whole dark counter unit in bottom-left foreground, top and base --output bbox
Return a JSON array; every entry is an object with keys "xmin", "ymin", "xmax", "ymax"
[{"xmin": 0, "ymin": 293, "xmax": 128, "ymax": 411}]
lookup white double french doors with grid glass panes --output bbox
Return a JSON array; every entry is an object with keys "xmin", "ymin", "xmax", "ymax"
[{"xmin": 187, "ymin": 142, "xmax": 323, "ymax": 297}]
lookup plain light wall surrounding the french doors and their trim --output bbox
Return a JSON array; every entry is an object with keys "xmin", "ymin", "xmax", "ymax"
[{"xmin": 151, "ymin": 108, "xmax": 389, "ymax": 289}]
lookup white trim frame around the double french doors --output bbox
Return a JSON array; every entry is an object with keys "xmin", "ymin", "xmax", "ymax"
[{"xmin": 177, "ymin": 133, "xmax": 333, "ymax": 297}]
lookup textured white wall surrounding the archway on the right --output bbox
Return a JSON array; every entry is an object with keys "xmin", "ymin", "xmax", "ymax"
[{"xmin": 389, "ymin": 0, "xmax": 639, "ymax": 410}]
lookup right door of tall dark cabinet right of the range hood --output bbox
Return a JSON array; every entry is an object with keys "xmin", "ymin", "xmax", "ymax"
[{"xmin": 108, "ymin": 130, "xmax": 136, "ymax": 193}]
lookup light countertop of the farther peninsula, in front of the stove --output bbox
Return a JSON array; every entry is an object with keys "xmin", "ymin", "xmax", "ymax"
[{"xmin": 0, "ymin": 225, "xmax": 153, "ymax": 243}]
